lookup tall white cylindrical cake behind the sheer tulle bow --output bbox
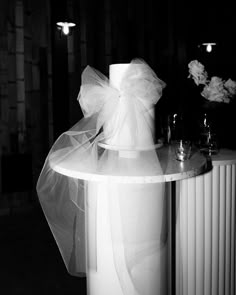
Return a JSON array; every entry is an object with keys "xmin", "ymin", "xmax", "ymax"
[{"xmin": 104, "ymin": 63, "xmax": 154, "ymax": 150}]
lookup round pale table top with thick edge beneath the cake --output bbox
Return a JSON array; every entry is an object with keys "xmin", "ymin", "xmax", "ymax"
[{"xmin": 51, "ymin": 146, "xmax": 209, "ymax": 183}]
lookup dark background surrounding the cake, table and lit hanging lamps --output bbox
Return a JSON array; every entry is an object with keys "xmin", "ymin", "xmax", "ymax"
[{"xmin": 0, "ymin": 0, "xmax": 236, "ymax": 295}]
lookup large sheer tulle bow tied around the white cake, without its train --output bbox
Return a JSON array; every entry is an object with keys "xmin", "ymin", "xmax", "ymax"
[{"xmin": 78, "ymin": 60, "xmax": 165, "ymax": 142}]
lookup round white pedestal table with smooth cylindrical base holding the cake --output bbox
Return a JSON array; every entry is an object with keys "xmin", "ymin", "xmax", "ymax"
[{"xmin": 50, "ymin": 146, "xmax": 207, "ymax": 295}]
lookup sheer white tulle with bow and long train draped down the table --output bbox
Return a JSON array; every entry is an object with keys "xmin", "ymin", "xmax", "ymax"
[{"xmin": 37, "ymin": 60, "xmax": 167, "ymax": 295}]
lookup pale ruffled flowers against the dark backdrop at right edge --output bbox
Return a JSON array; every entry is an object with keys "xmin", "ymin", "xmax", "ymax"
[{"xmin": 188, "ymin": 60, "xmax": 236, "ymax": 103}]
